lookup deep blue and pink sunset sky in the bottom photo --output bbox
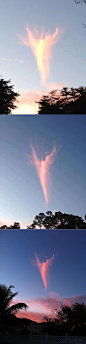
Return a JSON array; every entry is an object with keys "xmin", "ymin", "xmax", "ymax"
[{"xmin": 0, "ymin": 230, "xmax": 86, "ymax": 322}]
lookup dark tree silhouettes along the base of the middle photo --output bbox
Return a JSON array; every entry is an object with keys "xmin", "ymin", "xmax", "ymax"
[{"xmin": 27, "ymin": 211, "xmax": 86, "ymax": 229}]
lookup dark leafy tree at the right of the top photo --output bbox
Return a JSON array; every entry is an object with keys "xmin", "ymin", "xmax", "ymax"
[{"xmin": 36, "ymin": 87, "xmax": 86, "ymax": 114}]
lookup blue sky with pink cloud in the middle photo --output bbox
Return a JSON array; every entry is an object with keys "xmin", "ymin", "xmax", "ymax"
[{"xmin": 0, "ymin": 115, "xmax": 86, "ymax": 229}]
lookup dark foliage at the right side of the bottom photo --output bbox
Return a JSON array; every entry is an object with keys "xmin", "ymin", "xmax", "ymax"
[{"xmin": 42, "ymin": 302, "xmax": 86, "ymax": 336}]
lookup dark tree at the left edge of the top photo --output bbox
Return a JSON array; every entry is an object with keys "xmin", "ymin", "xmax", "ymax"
[{"xmin": 0, "ymin": 79, "xmax": 20, "ymax": 115}]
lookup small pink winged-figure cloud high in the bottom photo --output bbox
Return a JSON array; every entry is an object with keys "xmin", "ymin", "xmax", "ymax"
[{"xmin": 35, "ymin": 254, "xmax": 54, "ymax": 290}]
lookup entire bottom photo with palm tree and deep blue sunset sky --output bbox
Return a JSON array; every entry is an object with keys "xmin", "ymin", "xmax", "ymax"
[{"xmin": 0, "ymin": 229, "xmax": 86, "ymax": 344}]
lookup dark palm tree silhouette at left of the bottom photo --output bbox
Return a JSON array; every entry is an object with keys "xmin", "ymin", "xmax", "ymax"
[{"xmin": 0, "ymin": 284, "xmax": 28, "ymax": 318}]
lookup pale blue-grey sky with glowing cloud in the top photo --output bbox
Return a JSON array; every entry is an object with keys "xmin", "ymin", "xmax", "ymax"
[{"xmin": 0, "ymin": 0, "xmax": 86, "ymax": 114}]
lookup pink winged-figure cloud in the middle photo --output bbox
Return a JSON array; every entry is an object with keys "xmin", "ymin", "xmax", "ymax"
[{"xmin": 26, "ymin": 143, "xmax": 56, "ymax": 204}]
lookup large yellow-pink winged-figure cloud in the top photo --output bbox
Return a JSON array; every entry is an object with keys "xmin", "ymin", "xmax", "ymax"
[{"xmin": 18, "ymin": 26, "xmax": 60, "ymax": 84}]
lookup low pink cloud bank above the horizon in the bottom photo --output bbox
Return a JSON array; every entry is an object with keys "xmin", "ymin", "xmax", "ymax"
[{"xmin": 12, "ymin": 292, "xmax": 86, "ymax": 322}]
